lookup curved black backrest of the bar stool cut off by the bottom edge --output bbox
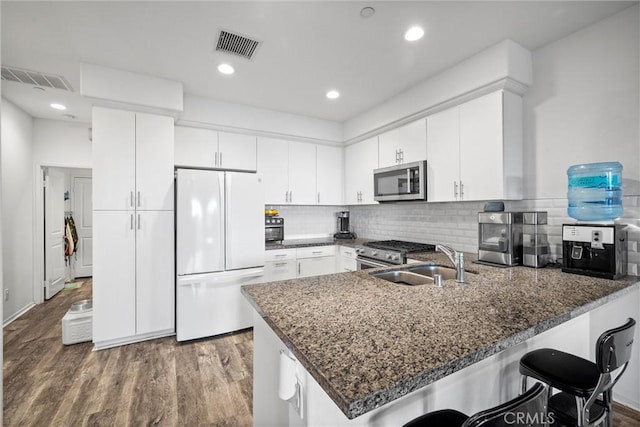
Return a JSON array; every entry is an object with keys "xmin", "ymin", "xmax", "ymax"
[{"xmin": 462, "ymin": 383, "xmax": 547, "ymax": 427}]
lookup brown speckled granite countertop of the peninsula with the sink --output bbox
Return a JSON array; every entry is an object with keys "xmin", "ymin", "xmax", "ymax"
[{"xmin": 242, "ymin": 253, "xmax": 640, "ymax": 418}]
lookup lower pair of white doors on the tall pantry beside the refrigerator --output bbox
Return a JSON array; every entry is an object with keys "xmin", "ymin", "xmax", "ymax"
[{"xmin": 93, "ymin": 211, "xmax": 175, "ymax": 348}]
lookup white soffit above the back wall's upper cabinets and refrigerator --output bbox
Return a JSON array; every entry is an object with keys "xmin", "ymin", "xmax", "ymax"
[{"xmin": 176, "ymin": 94, "xmax": 343, "ymax": 143}]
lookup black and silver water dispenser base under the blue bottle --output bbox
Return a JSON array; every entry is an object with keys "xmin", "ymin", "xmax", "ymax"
[{"xmin": 562, "ymin": 224, "xmax": 627, "ymax": 279}]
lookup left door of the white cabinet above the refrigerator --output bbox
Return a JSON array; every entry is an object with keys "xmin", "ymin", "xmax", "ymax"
[{"xmin": 174, "ymin": 126, "xmax": 218, "ymax": 168}]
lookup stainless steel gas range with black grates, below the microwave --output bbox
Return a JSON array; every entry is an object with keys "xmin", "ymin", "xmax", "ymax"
[{"xmin": 356, "ymin": 240, "xmax": 436, "ymax": 270}]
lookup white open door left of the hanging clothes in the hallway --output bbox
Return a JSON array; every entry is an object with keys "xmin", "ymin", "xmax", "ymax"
[{"xmin": 44, "ymin": 168, "xmax": 65, "ymax": 299}]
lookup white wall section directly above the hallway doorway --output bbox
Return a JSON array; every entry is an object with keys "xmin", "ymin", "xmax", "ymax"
[{"xmin": 33, "ymin": 119, "xmax": 92, "ymax": 168}]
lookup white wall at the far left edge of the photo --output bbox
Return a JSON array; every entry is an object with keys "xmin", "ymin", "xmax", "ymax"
[{"xmin": 1, "ymin": 98, "xmax": 34, "ymax": 321}]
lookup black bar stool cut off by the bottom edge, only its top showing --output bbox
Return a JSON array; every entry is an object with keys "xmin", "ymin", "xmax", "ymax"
[{"xmin": 403, "ymin": 383, "xmax": 547, "ymax": 427}]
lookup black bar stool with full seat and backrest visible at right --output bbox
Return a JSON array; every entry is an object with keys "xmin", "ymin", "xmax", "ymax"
[{"xmin": 520, "ymin": 318, "xmax": 636, "ymax": 427}]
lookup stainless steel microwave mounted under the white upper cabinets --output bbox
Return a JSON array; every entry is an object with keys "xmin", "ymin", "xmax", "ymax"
[{"xmin": 373, "ymin": 160, "xmax": 427, "ymax": 202}]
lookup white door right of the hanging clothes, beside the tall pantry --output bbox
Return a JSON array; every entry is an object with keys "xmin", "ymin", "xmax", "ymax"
[{"xmin": 72, "ymin": 176, "xmax": 93, "ymax": 277}]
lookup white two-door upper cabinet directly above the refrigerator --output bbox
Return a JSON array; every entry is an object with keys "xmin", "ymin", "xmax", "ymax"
[{"xmin": 175, "ymin": 126, "xmax": 257, "ymax": 172}]
